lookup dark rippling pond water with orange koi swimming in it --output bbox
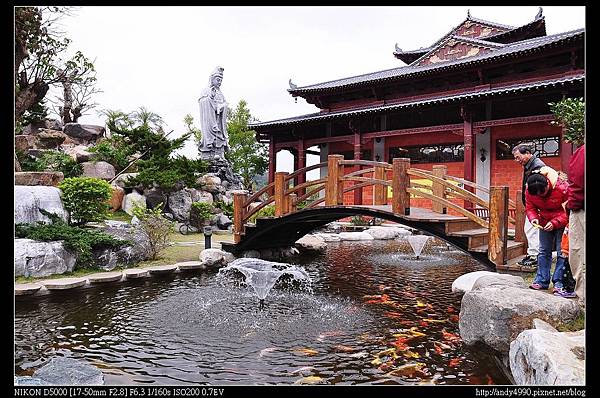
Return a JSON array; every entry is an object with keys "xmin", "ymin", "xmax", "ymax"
[{"xmin": 15, "ymin": 238, "xmax": 510, "ymax": 385}]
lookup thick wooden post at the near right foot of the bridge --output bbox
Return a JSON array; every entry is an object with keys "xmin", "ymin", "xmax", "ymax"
[{"xmin": 488, "ymin": 187, "xmax": 508, "ymax": 265}]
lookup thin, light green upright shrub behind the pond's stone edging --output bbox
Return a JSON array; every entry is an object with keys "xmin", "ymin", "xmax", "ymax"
[{"xmin": 133, "ymin": 203, "xmax": 175, "ymax": 260}]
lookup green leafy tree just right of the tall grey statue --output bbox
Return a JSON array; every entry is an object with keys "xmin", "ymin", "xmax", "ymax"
[{"xmin": 225, "ymin": 100, "xmax": 269, "ymax": 190}]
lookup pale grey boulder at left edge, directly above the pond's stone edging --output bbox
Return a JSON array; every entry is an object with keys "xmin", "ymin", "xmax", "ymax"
[{"xmin": 15, "ymin": 239, "xmax": 77, "ymax": 278}]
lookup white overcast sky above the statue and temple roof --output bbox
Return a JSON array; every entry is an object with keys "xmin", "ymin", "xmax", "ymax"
[{"xmin": 52, "ymin": 6, "xmax": 585, "ymax": 171}]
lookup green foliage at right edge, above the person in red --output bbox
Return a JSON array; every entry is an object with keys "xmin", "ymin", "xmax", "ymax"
[{"xmin": 548, "ymin": 98, "xmax": 585, "ymax": 145}]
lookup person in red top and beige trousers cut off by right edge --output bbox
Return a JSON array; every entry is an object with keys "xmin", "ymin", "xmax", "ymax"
[{"xmin": 567, "ymin": 144, "xmax": 585, "ymax": 307}]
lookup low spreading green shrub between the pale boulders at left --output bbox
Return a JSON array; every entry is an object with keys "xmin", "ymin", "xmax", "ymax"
[{"xmin": 15, "ymin": 209, "xmax": 131, "ymax": 268}]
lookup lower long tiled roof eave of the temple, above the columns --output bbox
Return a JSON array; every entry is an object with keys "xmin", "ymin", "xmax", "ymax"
[{"xmin": 262, "ymin": 73, "xmax": 585, "ymax": 133}]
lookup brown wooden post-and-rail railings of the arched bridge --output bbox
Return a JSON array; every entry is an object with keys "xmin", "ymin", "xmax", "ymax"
[{"xmin": 234, "ymin": 155, "xmax": 525, "ymax": 261}]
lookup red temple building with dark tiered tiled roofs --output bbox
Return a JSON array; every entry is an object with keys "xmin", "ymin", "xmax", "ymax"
[{"xmin": 251, "ymin": 8, "xmax": 585, "ymax": 208}]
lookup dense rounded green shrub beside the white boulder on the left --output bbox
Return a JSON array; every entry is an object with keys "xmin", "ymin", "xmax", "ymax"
[{"xmin": 58, "ymin": 177, "xmax": 112, "ymax": 225}]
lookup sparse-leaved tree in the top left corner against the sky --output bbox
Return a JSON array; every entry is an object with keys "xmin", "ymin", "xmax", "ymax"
[{"xmin": 14, "ymin": 7, "xmax": 96, "ymax": 123}]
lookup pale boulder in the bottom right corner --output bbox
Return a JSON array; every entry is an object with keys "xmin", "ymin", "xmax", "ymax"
[{"xmin": 509, "ymin": 329, "xmax": 585, "ymax": 385}]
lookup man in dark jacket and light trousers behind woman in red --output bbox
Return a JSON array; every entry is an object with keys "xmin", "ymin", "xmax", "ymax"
[{"xmin": 512, "ymin": 144, "xmax": 546, "ymax": 267}]
